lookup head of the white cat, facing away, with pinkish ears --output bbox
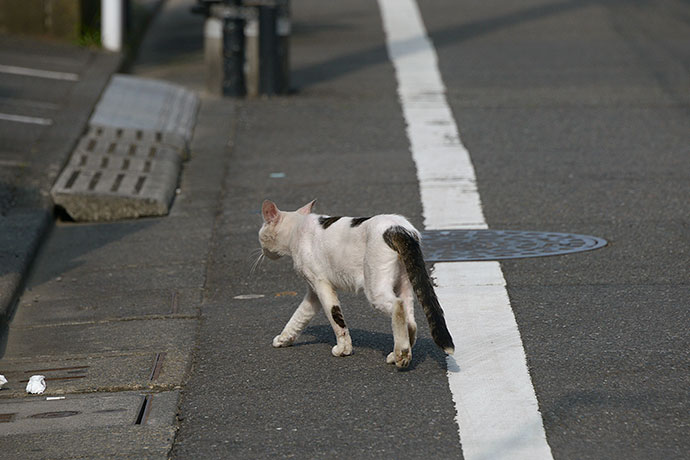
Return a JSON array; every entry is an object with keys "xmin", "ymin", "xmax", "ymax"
[{"xmin": 259, "ymin": 200, "xmax": 316, "ymax": 260}]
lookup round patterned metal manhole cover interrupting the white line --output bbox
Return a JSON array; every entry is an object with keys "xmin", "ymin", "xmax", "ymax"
[{"xmin": 422, "ymin": 230, "xmax": 606, "ymax": 262}]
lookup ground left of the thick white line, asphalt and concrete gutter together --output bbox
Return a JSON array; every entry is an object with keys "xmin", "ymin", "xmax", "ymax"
[{"xmin": 6, "ymin": 0, "xmax": 460, "ymax": 459}]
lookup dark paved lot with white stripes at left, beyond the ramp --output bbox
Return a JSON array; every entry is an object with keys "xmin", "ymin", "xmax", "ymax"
[{"xmin": 0, "ymin": 37, "xmax": 122, "ymax": 335}]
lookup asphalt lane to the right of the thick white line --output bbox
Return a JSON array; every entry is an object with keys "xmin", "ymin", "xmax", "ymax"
[{"xmin": 421, "ymin": 1, "xmax": 690, "ymax": 459}]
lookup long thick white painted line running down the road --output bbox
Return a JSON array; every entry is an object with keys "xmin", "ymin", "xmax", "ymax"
[{"xmin": 379, "ymin": 0, "xmax": 552, "ymax": 460}]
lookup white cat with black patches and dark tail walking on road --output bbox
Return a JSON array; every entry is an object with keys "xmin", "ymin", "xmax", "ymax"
[{"xmin": 259, "ymin": 200, "xmax": 455, "ymax": 368}]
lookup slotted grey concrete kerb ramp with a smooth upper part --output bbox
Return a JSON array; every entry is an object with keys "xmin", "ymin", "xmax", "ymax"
[{"xmin": 51, "ymin": 75, "xmax": 199, "ymax": 221}]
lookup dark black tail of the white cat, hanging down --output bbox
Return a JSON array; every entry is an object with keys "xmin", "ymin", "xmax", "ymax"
[{"xmin": 383, "ymin": 226, "xmax": 455, "ymax": 355}]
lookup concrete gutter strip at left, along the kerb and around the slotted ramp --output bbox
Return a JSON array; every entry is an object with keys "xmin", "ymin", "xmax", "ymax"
[{"xmin": 0, "ymin": 1, "xmax": 215, "ymax": 458}]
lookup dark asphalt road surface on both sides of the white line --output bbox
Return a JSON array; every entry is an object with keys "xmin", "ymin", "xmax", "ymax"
[{"xmin": 139, "ymin": 0, "xmax": 690, "ymax": 459}]
